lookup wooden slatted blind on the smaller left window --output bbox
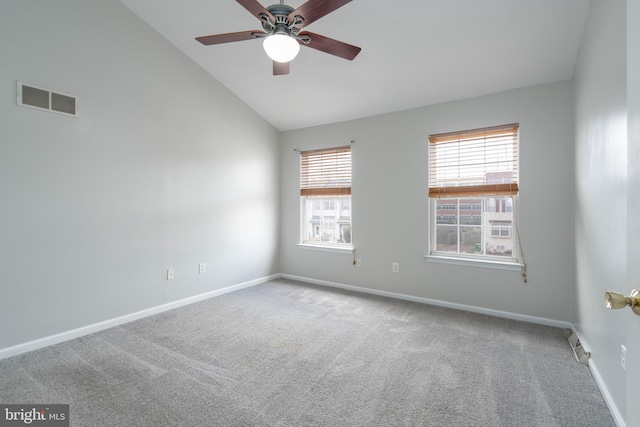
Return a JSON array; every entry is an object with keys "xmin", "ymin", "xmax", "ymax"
[{"xmin": 300, "ymin": 146, "xmax": 351, "ymax": 197}]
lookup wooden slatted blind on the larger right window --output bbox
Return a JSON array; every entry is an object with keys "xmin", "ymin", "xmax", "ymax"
[{"xmin": 429, "ymin": 123, "xmax": 519, "ymax": 197}]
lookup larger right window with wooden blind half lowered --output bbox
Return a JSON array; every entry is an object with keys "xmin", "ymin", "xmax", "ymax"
[{"xmin": 428, "ymin": 124, "xmax": 519, "ymax": 263}]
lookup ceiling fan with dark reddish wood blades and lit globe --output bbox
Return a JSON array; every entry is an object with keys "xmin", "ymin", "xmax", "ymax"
[{"xmin": 196, "ymin": 0, "xmax": 361, "ymax": 76}]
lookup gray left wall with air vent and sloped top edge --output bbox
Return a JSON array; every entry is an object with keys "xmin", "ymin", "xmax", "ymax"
[{"xmin": 0, "ymin": 0, "xmax": 279, "ymax": 349}]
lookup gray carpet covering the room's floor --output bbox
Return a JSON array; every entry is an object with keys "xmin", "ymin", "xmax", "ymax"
[{"xmin": 0, "ymin": 280, "xmax": 615, "ymax": 427}]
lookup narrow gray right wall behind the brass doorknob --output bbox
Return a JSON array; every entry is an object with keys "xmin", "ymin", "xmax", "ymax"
[{"xmin": 574, "ymin": 0, "xmax": 631, "ymax": 422}]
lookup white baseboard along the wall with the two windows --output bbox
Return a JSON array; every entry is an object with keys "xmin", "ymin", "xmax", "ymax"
[{"xmin": 280, "ymin": 274, "xmax": 573, "ymax": 329}]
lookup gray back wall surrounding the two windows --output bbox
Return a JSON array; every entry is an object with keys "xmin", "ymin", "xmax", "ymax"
[{"xmin": 281, "ymin": 82, "xmax": 574, "ymax": 322}]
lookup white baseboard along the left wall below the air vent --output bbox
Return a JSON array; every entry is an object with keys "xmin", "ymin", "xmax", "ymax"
[{"xmin": 0, "ymin": 274, "xmax": 280, "ymax": 360}]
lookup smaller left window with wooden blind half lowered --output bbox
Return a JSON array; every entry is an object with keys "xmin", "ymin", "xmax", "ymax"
[{"xmin": 300, "ymin": 147, "xmax": 352, "ymax": 249}]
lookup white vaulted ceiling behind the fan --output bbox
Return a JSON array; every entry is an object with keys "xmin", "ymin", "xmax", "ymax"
[{"xmin": 121, "ymin": 0, "xmax": 590, "ymax": 130}]
